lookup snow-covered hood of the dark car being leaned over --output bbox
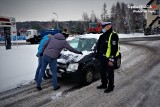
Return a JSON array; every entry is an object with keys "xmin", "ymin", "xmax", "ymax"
[{"xmin": 57, "ymin": 50, "xmax": 92, "ymax": 64}]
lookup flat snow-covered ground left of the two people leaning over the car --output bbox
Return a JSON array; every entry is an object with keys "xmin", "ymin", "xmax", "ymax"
[{"xmin": 0, "ymin": 45, "xmax": 38, "ymax": 91}]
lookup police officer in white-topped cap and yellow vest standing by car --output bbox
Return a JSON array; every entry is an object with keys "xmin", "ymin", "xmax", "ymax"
[{"xmin": 96, "ymin": 22, "xmax": 119, "ymax": 93}]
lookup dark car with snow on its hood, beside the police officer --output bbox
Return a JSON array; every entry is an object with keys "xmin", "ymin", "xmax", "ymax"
[{"xmin": 46, "ymin": 34, "xmax": 121, "ymax": 84}]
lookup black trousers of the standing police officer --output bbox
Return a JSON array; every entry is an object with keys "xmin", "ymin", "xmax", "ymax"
[{"xmin": 100, "ymin": 57, "xmax": 114, "ymax": 87}]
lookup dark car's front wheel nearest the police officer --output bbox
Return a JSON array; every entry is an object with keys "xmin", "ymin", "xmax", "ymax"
[{"xmin": 84, "ymin": 67, "xmax": 94, "ymax": 84}]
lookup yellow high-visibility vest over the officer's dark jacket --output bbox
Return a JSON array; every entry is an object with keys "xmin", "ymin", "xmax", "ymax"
[{"xmin": 106, "ymin": 32, "xmax": 120, "ymax": 58}]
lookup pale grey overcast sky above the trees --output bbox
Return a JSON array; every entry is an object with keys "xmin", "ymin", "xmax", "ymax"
[{"xmin": 0, "ymin": 0, "xmax": 149, "ymax": 21}]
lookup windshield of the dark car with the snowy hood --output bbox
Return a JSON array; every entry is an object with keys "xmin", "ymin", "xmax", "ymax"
[{"xmin": 69, "ymin": 38, "xmax": 97, "ymax": 51}]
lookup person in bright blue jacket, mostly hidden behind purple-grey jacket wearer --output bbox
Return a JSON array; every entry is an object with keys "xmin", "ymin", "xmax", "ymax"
[{"xmin": 34, "ymin": 34, "xmax": 52, "ymax": 81}]
